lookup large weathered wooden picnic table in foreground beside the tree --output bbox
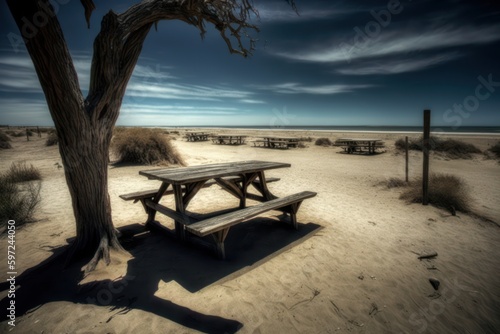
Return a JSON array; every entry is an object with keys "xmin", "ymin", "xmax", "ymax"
[{"xmin": 120, "ymin": 160, "xmax": 316, "ymax": 259}]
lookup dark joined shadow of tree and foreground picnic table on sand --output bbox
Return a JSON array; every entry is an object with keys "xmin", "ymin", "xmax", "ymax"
[{"xmin": 0, "ymin": 218, "xmax": 320, "ymax": 333}]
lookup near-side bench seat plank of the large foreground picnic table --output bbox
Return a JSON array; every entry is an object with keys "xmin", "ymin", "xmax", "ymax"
[{"xmin": 186, "ymin": 191, "xmax": 316, "ymax": 237}]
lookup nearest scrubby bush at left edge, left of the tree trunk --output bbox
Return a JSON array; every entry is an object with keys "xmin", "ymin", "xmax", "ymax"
[{"xmin": 0, "ymin": 174, "xmax": 41, "ymax": 233}]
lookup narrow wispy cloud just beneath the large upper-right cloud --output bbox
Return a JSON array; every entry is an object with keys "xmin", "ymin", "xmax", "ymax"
[{"xmin": 336, "ymin": 53, "xmax": 460, "ymax": 75}]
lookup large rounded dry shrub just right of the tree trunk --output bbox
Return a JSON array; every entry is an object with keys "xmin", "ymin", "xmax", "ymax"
[{"xmin": 112, "ymin": 128, "xmax": 185, "ymax": 165}]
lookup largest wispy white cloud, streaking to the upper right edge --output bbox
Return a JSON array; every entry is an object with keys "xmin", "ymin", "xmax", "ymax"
[{"xmin": 274, "ymin": 25, "xmax": 500, "ymax": 63}]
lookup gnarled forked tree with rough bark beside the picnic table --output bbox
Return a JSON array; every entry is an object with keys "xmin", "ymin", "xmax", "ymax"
[{"xmin": 6, "ymin": 0, "xmax": 294, "ymax": 272}]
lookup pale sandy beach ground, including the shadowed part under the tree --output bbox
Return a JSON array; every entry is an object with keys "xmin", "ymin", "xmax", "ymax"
[{"xmin": 0, "ymin": 129, "xmax": 500, "ymax": 333}]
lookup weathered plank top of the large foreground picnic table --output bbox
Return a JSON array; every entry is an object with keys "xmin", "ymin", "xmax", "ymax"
[{"xmin": 139, "ymin": 160, "xmax": 291, "ymax": 185}]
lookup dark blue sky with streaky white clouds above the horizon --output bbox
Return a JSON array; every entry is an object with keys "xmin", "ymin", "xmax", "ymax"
[{"xmin": 0, "ymin": 0, "xmax": 500, "ymax": 128}]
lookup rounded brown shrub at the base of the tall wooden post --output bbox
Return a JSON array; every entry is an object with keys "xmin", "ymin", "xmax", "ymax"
[{"xmin": 400, "ymin": 174, "xmax": 471, "ymax": 214}]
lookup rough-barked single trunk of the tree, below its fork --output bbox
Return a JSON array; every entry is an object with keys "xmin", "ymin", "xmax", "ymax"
[{"xmin": 59, "ymin": 115, "xmax": 121, "ymax": 272}]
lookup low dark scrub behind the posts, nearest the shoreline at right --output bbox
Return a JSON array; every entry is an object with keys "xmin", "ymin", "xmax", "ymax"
[{"xmin": 394, "ymin": 136, "xmax": 481, "ymax": 159}]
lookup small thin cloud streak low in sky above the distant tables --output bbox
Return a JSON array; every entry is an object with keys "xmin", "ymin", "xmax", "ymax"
[{"xmin": 255, "ymin": 82, "xmax": 372, "ymax": 95}]
